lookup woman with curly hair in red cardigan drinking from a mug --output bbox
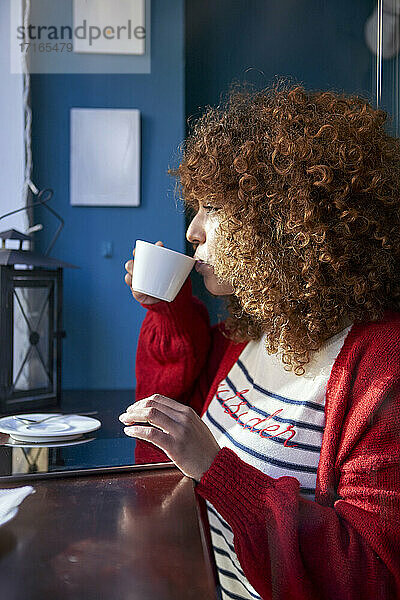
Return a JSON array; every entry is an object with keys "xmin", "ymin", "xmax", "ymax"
[{"xmin": 120, "ymin": 82, "xmax": 400, "ymax": 600}]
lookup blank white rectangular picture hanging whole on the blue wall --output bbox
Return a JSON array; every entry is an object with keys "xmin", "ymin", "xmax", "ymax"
[{"xmin": 70, "ymin": 108, "xmax": 140, "ymax": 206}]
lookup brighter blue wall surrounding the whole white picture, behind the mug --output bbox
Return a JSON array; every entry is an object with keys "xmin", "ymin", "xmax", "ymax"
[{"xmin": 32, "ymin": 0, "xmax": 185, "ymax": 389}]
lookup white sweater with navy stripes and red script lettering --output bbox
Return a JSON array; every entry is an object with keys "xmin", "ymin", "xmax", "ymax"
[{"xmin": 202, "ymin": 327, "xmax": 350, "ymax": 600}]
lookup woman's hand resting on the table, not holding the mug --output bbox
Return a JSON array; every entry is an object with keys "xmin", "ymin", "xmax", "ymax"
[{"xmin": 119, "ymin": 394, "xmax": 220, "ymax": 481}]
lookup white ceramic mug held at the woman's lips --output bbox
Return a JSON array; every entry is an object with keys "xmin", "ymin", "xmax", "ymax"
[{"xmin": 132, "ymin": 240, "xmax": 196, "ymax": 302}]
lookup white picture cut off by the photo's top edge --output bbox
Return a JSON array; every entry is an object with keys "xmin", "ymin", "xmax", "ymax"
[{"xmin": 73, "ymin": 0, "xmax": 146, "ymax": 54}]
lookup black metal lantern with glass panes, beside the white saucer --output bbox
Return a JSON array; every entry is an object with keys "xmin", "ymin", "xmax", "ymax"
[{"xmin": 0, "ymin": 229, "xmax": 77, "ymax": 414}]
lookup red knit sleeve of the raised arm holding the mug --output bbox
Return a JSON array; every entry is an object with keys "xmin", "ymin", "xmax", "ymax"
[{"xmin": 135, "ymin": 279, "xmax": 228, "ymax": 464}]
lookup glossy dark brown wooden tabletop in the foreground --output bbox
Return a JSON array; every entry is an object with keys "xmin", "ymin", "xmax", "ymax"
[{"xmin": 0, "ymin": 392, "xmax": 216, "ymax": 600}]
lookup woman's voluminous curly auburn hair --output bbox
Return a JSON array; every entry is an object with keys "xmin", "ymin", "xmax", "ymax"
[{"xmin": 168, "ymin": 80, "xmax": 400, "ymax": 375}]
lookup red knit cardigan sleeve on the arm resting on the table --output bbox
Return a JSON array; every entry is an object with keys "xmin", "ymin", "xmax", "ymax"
[{"xmin": 196, "ymin": 324, "xmax": 400, "ymax": 600}]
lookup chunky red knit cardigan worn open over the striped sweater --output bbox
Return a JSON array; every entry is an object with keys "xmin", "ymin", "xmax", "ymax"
[{"xmin": 136, "ymin": 283, "xmax": 400, "ymax": 600}]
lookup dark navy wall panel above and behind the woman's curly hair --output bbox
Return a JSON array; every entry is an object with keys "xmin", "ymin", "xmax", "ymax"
[{"xmin": 186, "ymin": 0, "xmax": 378, "ymax": 322}]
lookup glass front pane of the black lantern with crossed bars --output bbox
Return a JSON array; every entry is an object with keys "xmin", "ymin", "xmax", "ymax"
[{"xmin": 12, "ymin": 284, "xmax": 52, "ymax": 391}]
